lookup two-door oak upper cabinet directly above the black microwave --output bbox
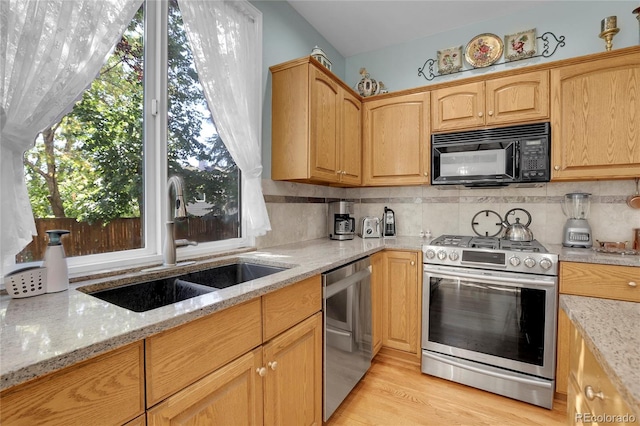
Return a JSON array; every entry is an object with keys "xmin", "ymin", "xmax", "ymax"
[{"xmin": 431, "ymin": 71, "xmax": 549, "ymax": 132}]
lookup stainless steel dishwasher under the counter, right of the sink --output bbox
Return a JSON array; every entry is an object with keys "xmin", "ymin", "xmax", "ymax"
[{"xmin": 322, "ymin": 257, "xmax": 372, "ymax": 421}]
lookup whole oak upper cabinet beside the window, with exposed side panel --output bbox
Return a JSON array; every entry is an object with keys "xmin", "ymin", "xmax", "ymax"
[{"xmin": 270, "ymin": 58, "xmax": 362, "ymax": 186}]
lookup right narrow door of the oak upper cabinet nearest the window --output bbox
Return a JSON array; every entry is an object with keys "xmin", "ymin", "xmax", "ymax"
[{"xmin": 340, "ymin": 90, "xmax": 362, "ymax": 185}]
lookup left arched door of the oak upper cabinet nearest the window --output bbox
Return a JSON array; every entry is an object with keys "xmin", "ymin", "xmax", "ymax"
[{"xmin": 309, "ymin": 67, "xmax": 340, "ymax": 182}]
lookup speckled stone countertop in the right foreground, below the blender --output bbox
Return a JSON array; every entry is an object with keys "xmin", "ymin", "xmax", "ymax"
[{"xmin": 560, "ymin": 294, "xmax": 640, "ymax": 418}]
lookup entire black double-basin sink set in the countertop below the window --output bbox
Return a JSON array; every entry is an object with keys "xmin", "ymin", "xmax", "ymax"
[{"xmin": 81, "ymin": 263, "xmax": 287, "ymax": 312}]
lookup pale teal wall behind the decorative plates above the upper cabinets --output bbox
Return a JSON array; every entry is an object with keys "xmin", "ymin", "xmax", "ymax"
[{"xmin": 345, "ymin": 0, "xmax": 640, "ymax": 92}]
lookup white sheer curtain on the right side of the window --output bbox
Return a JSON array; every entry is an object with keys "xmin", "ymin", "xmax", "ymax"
[{"xmin": 178, "ymin": 0, "xmax": 271, "ymax": 236}]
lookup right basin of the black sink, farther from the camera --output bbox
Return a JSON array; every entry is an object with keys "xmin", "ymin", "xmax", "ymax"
[{"xmin": 180, "ymin": 263, "xmax": 287, "ymax": 289}]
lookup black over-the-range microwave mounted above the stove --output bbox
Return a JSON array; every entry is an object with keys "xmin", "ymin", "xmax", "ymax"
[{"xmin": 431, "ymin": 123, "xmax": 551, "ymax": 187}]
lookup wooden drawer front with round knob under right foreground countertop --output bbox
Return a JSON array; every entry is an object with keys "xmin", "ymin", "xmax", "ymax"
[{"xmin": 570, "ymin": 327, "xmax": 631, "ymax": 415}]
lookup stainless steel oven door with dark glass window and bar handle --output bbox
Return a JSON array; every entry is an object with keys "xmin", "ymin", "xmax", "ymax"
[{"xmin": 422, "ymin": 265, "xmax": 558, "ymax": 380}]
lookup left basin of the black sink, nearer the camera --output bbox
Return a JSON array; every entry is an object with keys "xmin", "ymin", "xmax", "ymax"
[{"xmin": 88, "ymin": 277, "xmax": 215, "ymax": 312}]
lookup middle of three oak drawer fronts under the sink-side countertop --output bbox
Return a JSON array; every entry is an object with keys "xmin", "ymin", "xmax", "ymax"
[{"xmin": 145, "ymin": 298, "xmax": 262, "ymax": 407}]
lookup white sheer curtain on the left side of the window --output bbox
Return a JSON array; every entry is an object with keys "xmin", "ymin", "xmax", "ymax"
[{"xmin": 0, "ymin": 0, "xmax": 142, "ymax": 271}]
